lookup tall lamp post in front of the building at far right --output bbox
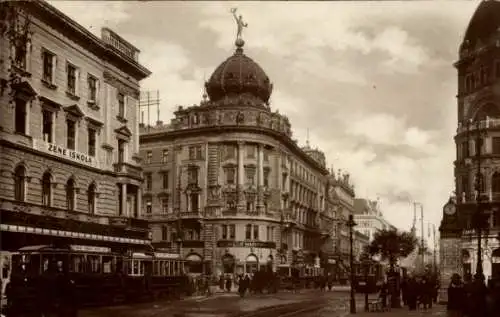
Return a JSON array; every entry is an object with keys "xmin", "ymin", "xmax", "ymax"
[{"xmin": 466, "ymin": 118, "xmax": 484, "ymax": 282}]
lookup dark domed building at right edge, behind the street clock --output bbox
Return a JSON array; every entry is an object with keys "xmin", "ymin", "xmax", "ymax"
[{"xmin": 440, "ymin": 1, "xmax": 500, "ymax": 295}]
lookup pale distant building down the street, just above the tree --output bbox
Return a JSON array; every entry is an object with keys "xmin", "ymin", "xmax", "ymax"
[{"xmin": 354, "ymin": 198, "xmax": 395, "ymax": 242}]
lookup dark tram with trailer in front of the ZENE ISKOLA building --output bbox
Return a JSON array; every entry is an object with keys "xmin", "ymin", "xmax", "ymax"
[{"xmin": 3, "ymin": 245, "xmax": 188, "ymax": 317}]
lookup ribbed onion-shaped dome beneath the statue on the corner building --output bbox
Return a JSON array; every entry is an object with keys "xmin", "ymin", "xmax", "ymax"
[{"xmin": 205, "ymin": 39, "xmax": 273, "ymax": 104}]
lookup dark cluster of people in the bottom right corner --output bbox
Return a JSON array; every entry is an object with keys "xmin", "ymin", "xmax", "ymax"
[{"xmin": 447, "ymin": 274, "xmax": 500, "ymax": 317}]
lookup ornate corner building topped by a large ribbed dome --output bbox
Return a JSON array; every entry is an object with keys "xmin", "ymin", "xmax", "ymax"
[{"xmin": 140, "ymin": 40, "xmax": 344, "ymax": 275}]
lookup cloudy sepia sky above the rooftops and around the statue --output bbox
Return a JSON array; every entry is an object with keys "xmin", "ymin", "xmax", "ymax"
[{"xmin": 49, "ymin": 0, "xmax": 479, "ymax": 237}]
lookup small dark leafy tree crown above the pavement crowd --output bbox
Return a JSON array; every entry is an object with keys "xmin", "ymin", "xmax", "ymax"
[{"xmin": 366, "ymin": 229, "xmax": 417, "ymax": 269}]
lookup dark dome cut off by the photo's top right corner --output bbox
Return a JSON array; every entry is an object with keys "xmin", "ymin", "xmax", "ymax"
[{"xmin": 463, "ymin": 0, "xmax": 500, "ymax": 47}]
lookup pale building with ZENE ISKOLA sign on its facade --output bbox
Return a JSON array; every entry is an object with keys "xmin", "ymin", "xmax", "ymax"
[{"xmin": 0, "ymin": 0, "xmax": 150, "ymax": 251}]
